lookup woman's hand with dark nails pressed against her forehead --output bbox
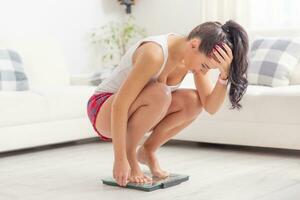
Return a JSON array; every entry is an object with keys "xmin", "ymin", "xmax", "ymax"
[{"xmin": 209, "ymin": 43, "xmax": 233, "ymax": 79}]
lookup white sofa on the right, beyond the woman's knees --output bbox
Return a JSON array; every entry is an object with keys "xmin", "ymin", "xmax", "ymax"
[{"xmin": 174, "ymin": 70, "xmax": 300, "ymax": 150}]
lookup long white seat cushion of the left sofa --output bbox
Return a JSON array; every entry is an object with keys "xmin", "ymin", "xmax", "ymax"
[{"xmin": 0, "ymin": 86, "xmax": 95, "ymax": 127}]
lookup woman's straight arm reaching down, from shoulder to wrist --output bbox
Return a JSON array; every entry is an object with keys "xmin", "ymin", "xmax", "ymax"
[{"xmin": 111, "ymin": 42, "xmax": 163, "ymax": 159}]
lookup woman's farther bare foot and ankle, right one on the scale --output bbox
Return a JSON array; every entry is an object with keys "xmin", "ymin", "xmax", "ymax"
[{"xmin": 137, "ymin": 146, "xmax": 170, "ymax": 178}]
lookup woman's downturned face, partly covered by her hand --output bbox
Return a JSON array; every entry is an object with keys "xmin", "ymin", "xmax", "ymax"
[{"xmin": 184, "ymin": 38, "xmax": 218, "ymax": 70}]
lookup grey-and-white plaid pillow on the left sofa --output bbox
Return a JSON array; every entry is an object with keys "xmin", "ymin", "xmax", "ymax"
[{"xmin": 0, "ymin": 49, "xmax": 29, "ymax": 91}]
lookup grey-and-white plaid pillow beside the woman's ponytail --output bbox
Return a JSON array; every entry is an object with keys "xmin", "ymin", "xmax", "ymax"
[{"xmin": 247, "ymin": 38, "xmax": 300, "ymax": 87}]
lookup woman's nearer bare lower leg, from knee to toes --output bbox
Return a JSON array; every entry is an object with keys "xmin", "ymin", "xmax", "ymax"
[{"xmin": 126, "ymin": 82, "xmax": 171, "ymax": 183}]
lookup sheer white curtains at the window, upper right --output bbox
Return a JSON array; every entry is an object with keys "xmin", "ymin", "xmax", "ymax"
[{"xmin": 202, "ymin": 0, "xmax": 300, "ymax": 31}]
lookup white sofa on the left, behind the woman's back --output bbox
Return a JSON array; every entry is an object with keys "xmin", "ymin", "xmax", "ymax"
[{"xmin": 0, "ymin": 36, "xmax": 96, "ymax": 152}]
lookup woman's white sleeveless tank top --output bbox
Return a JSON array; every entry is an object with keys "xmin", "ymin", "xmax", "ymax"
[{"xmin": 95, "ymin": 32, "xmax": 191, "ymax": 93}]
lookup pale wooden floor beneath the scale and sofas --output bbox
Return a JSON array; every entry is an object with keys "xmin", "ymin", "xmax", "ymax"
[{"xmin": 0, "ymin": 140, "xmax": 300, "ymax": 200}]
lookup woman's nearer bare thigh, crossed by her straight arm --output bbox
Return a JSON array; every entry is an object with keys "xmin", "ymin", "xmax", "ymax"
[{"xmin": 95, "ymin": 82, "xmax": 172, "ymax": 137}]
